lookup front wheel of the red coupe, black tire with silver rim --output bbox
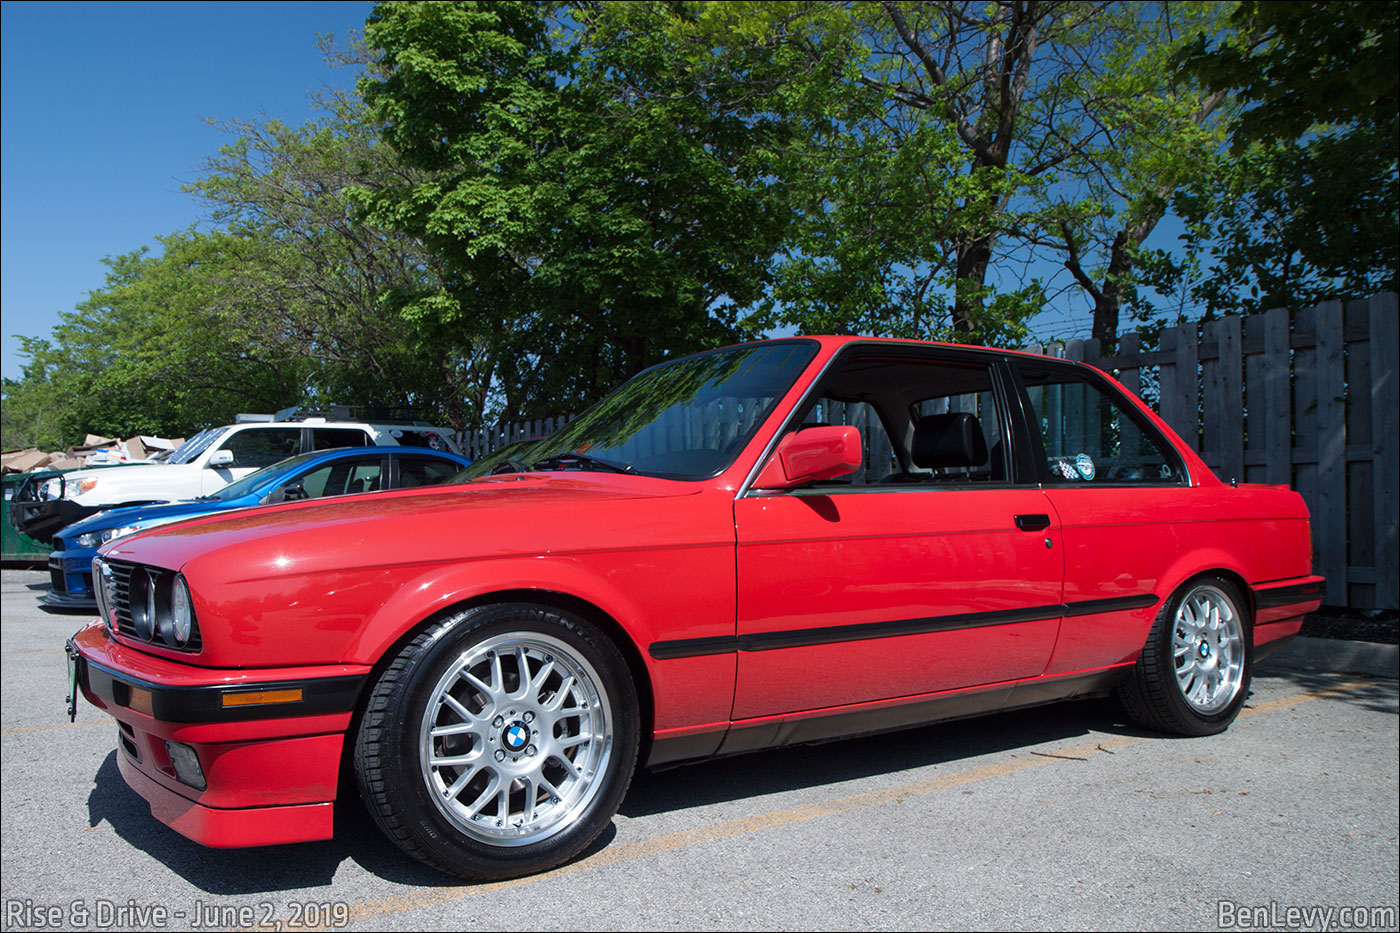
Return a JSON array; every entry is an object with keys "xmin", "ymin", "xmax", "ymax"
[{"xmin": 354, "ymin": 602, "xmax": 638, "ymax": 881}]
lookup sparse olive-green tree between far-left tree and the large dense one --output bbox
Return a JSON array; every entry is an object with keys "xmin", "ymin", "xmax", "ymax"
[{"xmin": 189, "ymin": 77, "xmax": 501, "ymax": 429}]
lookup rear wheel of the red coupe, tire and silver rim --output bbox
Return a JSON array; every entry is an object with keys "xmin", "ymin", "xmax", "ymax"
[{"xmin": 1117, "ymin": 576, "xmax": 1254, "ymax": 735}]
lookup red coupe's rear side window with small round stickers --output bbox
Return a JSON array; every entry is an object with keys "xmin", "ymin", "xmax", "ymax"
[{"xmin": 1018, "ymin": 363, "xmax": 1186, "ymax": 486}]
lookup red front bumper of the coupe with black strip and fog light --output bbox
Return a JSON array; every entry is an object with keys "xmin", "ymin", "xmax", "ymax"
[{"xmin": 69, "ymin": 622, "xmax": 370, "ymax": 848}]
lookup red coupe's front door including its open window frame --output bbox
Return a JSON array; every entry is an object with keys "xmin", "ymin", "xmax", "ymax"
[{"xmin": 734, "ymin": 345, "xmax": 1063, "ymax": 720}]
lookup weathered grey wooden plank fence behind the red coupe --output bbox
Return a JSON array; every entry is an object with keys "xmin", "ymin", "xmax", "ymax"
[{"xmin": 462, "ymin": 293, "xmax": 1400, "ymax": 609}]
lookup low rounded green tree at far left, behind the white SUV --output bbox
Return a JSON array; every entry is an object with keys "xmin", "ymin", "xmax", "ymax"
[{"xmin": 4, "ymin": 233, "xmax": 305, "ymax": 448}]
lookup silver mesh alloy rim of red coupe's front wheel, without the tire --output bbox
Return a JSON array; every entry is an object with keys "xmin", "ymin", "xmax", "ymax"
[{"xmin": 419, "ymin": 632, "xmax": 613, "ymax": 846}]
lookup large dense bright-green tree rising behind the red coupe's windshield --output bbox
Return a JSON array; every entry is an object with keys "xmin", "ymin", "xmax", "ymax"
[{"xmin": 361, "ymin": 1, "xmax": 785, "ymax": 416}]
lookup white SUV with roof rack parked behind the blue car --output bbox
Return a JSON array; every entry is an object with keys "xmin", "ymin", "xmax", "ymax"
[{"xmin": 14, "ymin": 409, "xmax": 461, "ymax": 542}]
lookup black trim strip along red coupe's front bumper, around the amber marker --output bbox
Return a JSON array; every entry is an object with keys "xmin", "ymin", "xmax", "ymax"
[{"xmin": 69, "ymin": 639, "xmax": 368, "ymax": 723}]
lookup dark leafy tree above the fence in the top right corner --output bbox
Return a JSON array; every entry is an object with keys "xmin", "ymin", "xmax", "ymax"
[{"xmin": 1158, "ymin": 1, "xmax": 1400, "ymax": 314}]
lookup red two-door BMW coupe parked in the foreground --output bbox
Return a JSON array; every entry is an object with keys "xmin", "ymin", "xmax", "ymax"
[{"xmin": 69, "ymin": 338, "xmax": 1320, "ymax": 878}]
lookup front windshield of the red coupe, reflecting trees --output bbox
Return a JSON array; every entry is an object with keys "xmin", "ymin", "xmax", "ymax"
[{"xmin": 518, "ymin": 340, "xmax": 816, "ymax": 479}]
